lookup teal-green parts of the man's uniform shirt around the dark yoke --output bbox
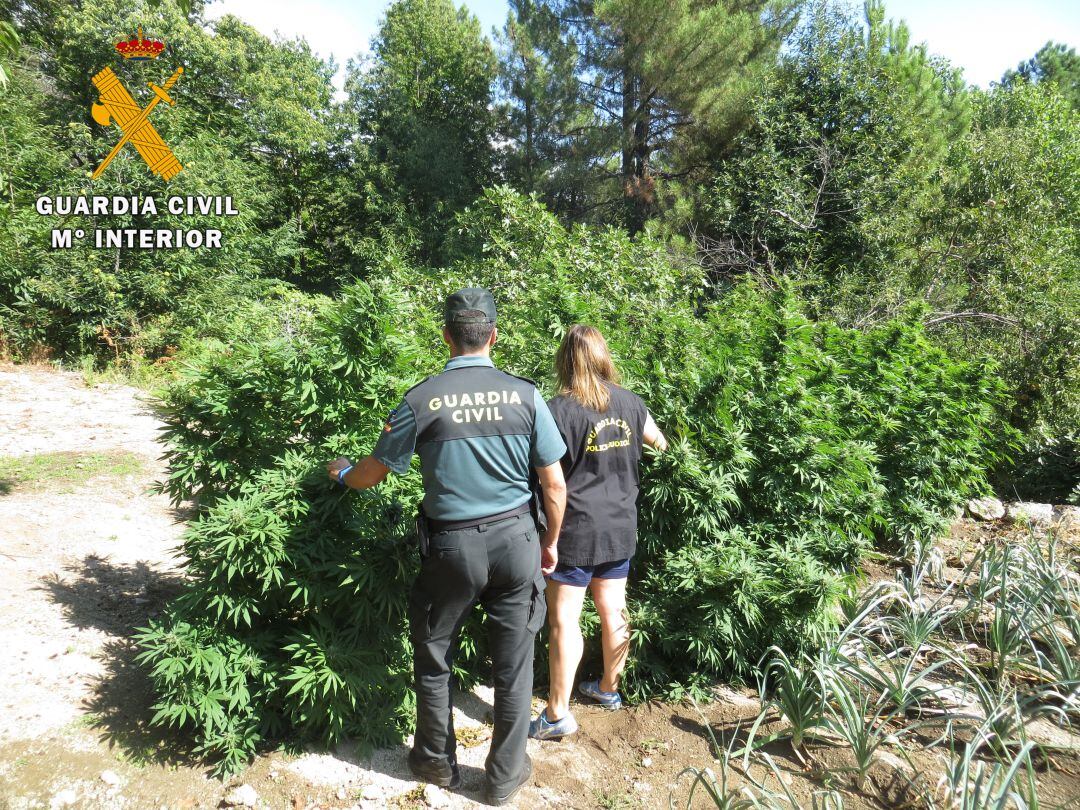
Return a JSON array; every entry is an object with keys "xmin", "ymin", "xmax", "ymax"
[{"xmin": 372, "ymin": 356, "xmax": 566, "ymax": 521}]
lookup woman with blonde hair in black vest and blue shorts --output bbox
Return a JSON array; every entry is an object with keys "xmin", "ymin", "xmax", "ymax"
[{"xmin": 529, "ymin": 324, "xmax": 667, "ymax": 740}]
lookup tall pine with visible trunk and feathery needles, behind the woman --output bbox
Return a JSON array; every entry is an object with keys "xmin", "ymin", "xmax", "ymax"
[{"xmin": 550, "ymin": 0, "xmax": 797, "ymax": 232}]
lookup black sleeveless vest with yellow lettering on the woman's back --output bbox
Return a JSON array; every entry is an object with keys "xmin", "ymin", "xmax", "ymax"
[{"xmin": 548, "ymin": 383, "xmax": 648, "ymax": 566}]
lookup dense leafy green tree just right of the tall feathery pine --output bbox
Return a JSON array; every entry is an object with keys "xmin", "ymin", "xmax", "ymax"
[{"xmin": 687, "ymin": 2, "xmax": 971, "ymax": 295}]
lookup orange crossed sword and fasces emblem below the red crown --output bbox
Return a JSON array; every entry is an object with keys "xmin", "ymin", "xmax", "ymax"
[{"xmin": 90, "ymin": 67, "xmax": 184, "ymax": 180}]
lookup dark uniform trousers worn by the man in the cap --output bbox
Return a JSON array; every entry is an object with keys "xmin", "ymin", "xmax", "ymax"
[{"xmin": 409, "ymin": 514, "xmax": 546, "ymax": 788}]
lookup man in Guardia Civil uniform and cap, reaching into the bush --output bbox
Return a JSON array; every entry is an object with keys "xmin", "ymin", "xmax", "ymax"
[{"xmin": 328, "ymin": 288, "xmax": 566, "ymax": 805}]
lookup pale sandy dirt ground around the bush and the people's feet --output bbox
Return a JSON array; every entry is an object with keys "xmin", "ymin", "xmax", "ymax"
[{"xmin": 0, "ymin": 366, "xmax": 1080, "ymax": 810}]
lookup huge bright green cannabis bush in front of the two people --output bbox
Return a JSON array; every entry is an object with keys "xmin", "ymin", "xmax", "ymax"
[{"xmin": 139, "ymin": 189, "xmax": 1001, "ymax": 769}]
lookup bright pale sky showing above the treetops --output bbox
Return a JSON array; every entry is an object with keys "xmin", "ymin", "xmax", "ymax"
[{"xmin": 207, "ymin": 0, "xmax": 1080, "ymax": 92}]
